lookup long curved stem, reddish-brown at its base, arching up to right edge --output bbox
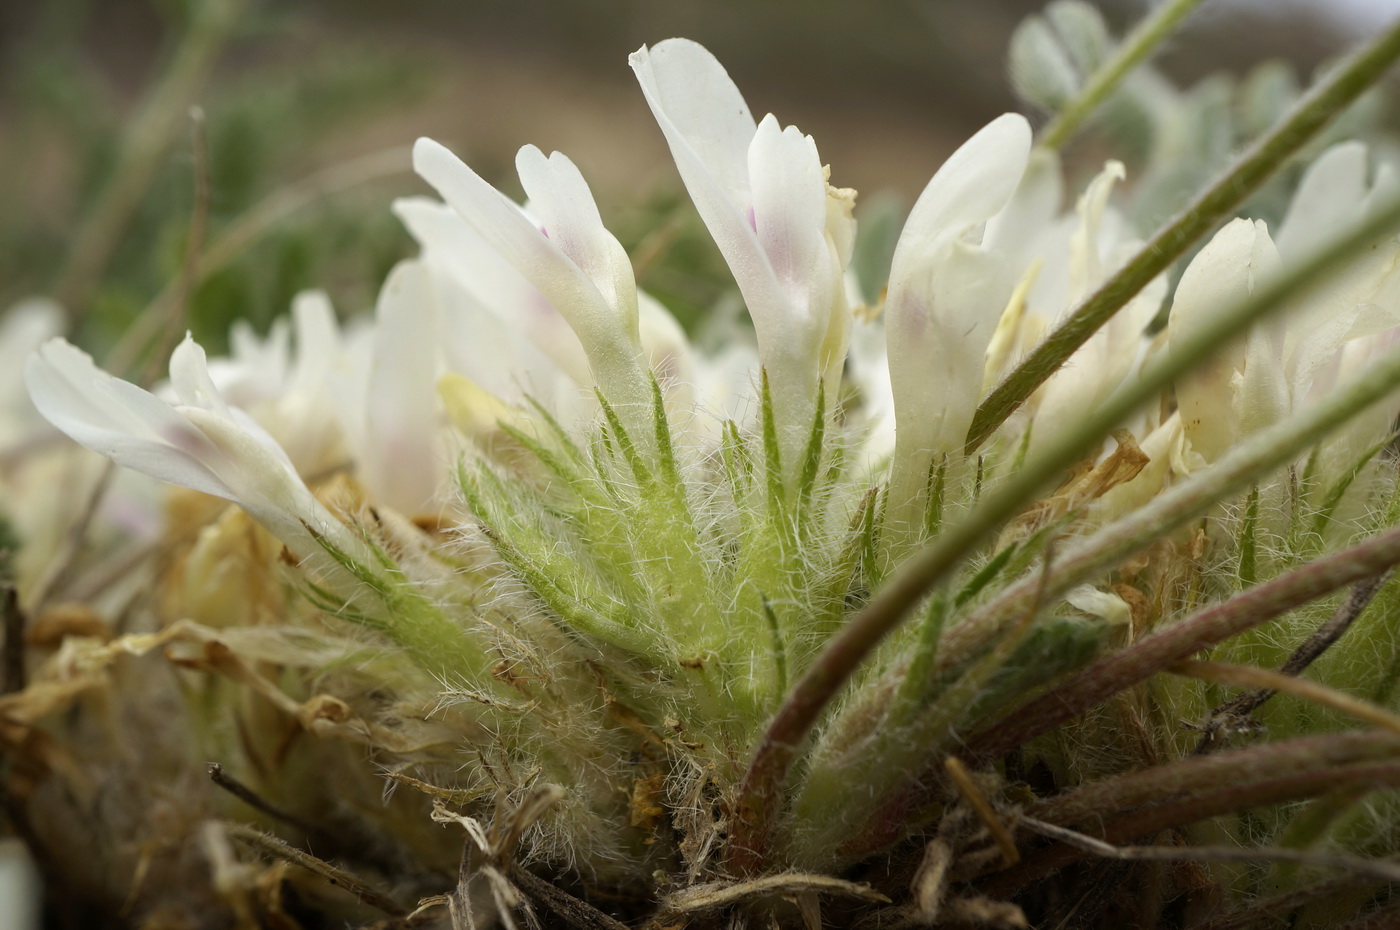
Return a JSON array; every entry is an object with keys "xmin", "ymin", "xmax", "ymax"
[{"xmin": 729, "ymin": 194, "xmax": 1400, "ymax": 874}]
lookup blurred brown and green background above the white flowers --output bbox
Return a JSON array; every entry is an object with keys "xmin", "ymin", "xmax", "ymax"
[{"xmin": 0, "ymin": 0, "xmax": 1400, "ymax": 355}]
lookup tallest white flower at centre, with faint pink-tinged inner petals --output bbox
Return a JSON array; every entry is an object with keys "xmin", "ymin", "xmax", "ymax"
[{"xmin": 630, "ymin": 39, "xmax": 854, "ymax": 462}]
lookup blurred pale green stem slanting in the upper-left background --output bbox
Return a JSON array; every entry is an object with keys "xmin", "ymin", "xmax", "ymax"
[{"xmin": 55, "ymin": 0, "xmax": 242, "ymax": 318}]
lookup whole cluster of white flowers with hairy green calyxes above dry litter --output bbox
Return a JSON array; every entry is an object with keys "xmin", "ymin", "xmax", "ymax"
[{"xmin": 8, "ymin": 16, "xmax": 1400, "ymax": 926}]
